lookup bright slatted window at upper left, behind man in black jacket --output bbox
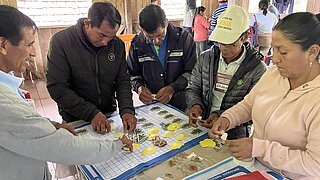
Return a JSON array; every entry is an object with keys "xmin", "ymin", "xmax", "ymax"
[{"xmin": 17, "ymin": 0, "xmax": 92, "ymax": 26}]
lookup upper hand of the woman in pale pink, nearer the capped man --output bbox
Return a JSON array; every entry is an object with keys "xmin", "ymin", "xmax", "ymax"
[{"xmin": 208, "ymin": 117, "xmax": 230, "ymax": 139}]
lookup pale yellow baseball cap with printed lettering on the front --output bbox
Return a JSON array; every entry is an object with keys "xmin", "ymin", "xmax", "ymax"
[{"xmin": 209, "ymin": 5, "xmax": 250, "ymax": 44}]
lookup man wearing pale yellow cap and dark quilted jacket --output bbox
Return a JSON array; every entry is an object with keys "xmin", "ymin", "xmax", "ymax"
[{"xmin": 186, "ymin": 6, "xmax": 267, "ymax": 139}]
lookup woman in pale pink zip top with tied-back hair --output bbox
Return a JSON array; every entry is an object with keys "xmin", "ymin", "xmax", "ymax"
[{"xmin": 209, "ymin": 12, "xmax": 320, "ymax": 179}]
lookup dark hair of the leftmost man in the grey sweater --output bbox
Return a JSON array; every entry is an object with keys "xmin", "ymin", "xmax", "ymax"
[{"xmin": 0, "ymin": 5, "xmax": 38, "ymax": 46}]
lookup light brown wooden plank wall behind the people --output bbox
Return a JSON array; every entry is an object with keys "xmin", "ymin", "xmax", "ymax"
[{"xmin": 0, "ymin": 0, "xmax": 320, "ymax": 78}]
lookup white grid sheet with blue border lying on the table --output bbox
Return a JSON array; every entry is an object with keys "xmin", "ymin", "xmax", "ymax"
[{"xmin": 77, "ymin": 102, "xmax": 208, "ymax": 179}]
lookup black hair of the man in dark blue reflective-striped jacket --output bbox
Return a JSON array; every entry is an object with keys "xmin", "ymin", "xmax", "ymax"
[{"xmin": 139, "ymin": 4, "xmax": 167, "ymax": 33}]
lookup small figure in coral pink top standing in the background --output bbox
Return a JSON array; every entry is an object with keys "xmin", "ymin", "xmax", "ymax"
[{"xmin": 192, "ymin": 6, "xmax": 210, "ymax": 57}]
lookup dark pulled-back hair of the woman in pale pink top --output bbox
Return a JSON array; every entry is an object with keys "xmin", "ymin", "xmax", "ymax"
[{"xmin": 274, "ymin": 12, "xmax": 320, "ymax": 51}]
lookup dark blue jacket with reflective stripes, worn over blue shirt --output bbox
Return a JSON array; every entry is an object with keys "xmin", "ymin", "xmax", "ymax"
[{"xmin": 127, "ymin": 23, "xmax": 196, "ymax": 111}]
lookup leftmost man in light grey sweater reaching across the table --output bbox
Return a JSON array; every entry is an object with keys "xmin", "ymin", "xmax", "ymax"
[{"xmin": 0, "ymin": 5, "xmax": 132, "ymax": 180}]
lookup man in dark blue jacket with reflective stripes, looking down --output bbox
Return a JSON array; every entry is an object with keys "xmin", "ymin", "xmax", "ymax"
[{"xmin": 127, "ymin": 4, "xmax": 196, "ymax": 111}]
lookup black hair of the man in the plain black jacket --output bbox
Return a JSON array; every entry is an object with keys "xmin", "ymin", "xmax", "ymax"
[{"xmin": 88, "ymin": 2, "xmax": 121, "ymax": 28}]
